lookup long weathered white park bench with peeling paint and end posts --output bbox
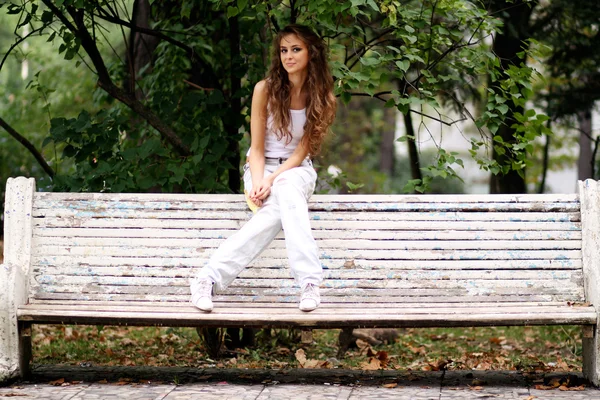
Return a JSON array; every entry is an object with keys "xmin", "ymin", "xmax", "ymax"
[{"xmin": 0, "ymin": 178, "xmax": 600, "ymax": 384}]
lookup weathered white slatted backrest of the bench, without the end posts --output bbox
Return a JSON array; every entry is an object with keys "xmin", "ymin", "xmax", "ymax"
[{"xmin": 25, "ymin": 193, "xmax": 584, "ymax": 303}]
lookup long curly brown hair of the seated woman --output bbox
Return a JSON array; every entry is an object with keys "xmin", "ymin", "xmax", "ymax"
[{"xmin": 267, "ymin": 24, "xmax": 336, "ymax": 157}]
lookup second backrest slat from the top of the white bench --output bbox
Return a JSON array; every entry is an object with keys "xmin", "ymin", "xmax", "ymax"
[{"xmin": 33, "ymin": 208, "xmax": 581, "ymax": 222}]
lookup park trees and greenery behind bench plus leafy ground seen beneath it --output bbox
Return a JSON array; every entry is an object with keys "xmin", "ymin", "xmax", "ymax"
[{"xmin": 0, "ymin": 0, "xmax": 600, "ymax": 378}]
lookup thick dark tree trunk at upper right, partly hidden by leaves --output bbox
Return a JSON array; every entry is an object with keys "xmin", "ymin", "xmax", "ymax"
[{"xmin": 490, "ymin": 0, "xmax": 537, "ymax": 193}]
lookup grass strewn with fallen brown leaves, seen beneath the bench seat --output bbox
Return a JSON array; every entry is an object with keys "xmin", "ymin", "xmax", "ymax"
[{"xmin": 33, "ymin": 325, "xmax": 582, "ymax": 372}]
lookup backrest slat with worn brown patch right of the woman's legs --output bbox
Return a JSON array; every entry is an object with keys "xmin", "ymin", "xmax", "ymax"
[{"xmin": 32, "ymin": 255, "xmax": 582, "ymax": 270}]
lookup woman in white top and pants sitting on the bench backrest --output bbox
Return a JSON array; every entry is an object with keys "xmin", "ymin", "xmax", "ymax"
[{"xmin": 190, "ymin": 25, "xmax": 336, "ymax": 312}]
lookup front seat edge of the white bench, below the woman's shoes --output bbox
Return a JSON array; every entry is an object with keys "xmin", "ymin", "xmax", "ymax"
[{"xmin": 17, "ymin": 307, "xmax": 596, "ymax": 328}]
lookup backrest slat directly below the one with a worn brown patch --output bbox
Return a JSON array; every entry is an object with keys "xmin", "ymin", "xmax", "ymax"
[{"xmin": 33, "ymin": 266, "xmax": 583, "ymax": 282}]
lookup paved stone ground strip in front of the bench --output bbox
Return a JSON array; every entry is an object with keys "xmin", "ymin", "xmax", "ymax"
[{"xmin": 0, "ymin": 366, "xmax": 600, "ymax": 400}]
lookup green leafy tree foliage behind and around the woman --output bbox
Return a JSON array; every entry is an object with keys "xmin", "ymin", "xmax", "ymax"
[{"xmin": 0, "ymin": 0, "xmax": 543, "ymax": 199}]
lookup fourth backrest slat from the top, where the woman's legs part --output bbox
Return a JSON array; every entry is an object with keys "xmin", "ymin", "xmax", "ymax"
[{"xmin": 34, "ymin": 226, "xmax": 581, "ymax": 240}]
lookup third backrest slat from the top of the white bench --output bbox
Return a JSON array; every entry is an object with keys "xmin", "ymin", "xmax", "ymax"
[{"xmin": 33, "ymin": 217, "xmax": 581, "ymax": 231}]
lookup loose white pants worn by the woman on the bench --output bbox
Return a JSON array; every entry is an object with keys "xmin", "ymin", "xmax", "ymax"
[{"xmin": 197, "ymin": 160, "xmax": 323, "ymax": 291}]
